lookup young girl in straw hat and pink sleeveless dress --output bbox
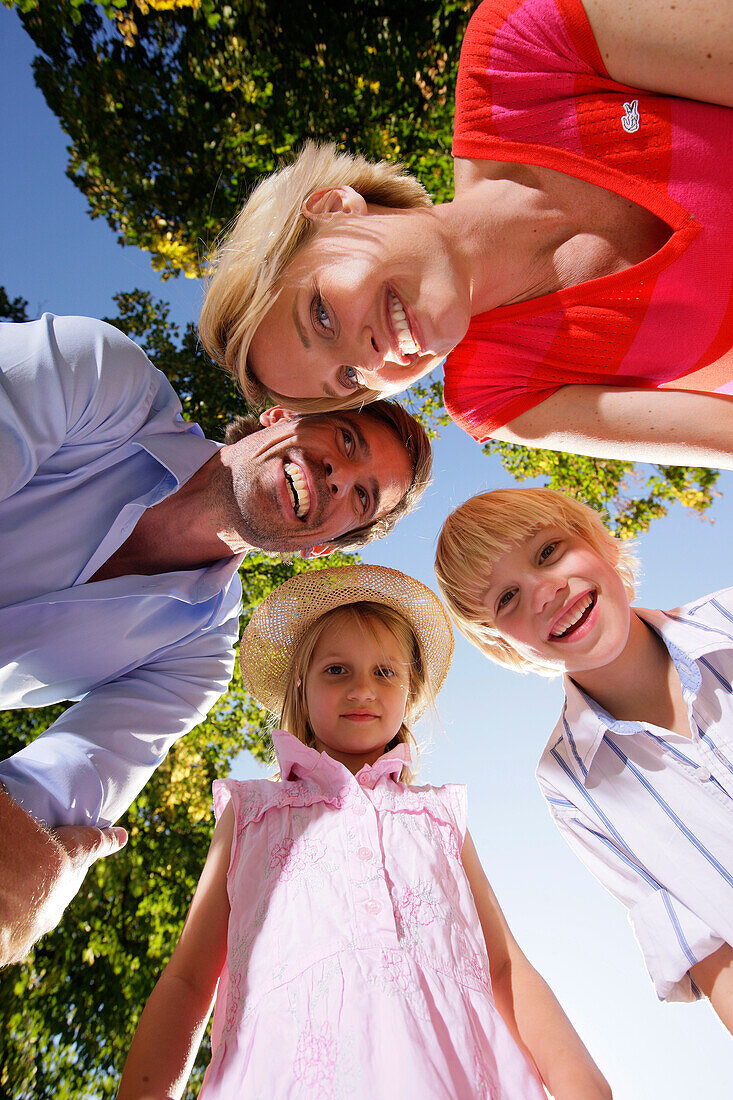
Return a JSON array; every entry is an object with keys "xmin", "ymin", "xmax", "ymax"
[{"xmin": 119, "ymin": 565, "xmax": 610, "ymax": 1100}]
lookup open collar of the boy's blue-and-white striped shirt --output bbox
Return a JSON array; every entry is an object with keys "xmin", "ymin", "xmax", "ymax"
[{"xmin": 554, "ymin": 607, "xmax": 704, "ymax": 782}]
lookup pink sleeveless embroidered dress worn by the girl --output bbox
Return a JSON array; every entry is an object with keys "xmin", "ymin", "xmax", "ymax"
[{"xmin": 199, "ymin": 732, "xmax": 546, "ymax": 1100}]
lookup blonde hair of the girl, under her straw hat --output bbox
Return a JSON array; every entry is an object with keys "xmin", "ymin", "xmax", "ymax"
[{"xmin": 280, "ymin": 601, "xmax": 434, "ymax": 783}]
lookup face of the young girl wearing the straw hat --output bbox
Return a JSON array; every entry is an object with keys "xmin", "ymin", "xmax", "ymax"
[{"xmin": 305, "ymin": 616, "xmax": 409, "ymax": 774}]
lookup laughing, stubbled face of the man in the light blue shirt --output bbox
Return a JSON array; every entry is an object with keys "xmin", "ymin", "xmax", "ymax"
[{"xmin": 222, "ymin": 409, "xmax": 413, "ymax": 551}]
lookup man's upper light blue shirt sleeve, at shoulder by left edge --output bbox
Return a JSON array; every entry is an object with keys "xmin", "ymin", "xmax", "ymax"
[{"xmin": 0, "ymin": 314, "xmax": 164, "ymax": 501}]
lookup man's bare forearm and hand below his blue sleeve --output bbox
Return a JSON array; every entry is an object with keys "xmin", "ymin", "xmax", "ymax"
[{"xmin": 0, "ymin": 790, "xmax": 128, "ymax": 966}]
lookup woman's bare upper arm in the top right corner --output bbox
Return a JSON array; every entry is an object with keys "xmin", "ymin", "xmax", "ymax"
[{"xmin": 582, "ymin": 0, "xmax": 733, "ymax": 107}]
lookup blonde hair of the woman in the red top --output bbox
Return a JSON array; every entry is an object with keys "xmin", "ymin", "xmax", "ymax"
[{"xmin": 199, "ymin": 141, "xmax": 431, "ymax": 413}]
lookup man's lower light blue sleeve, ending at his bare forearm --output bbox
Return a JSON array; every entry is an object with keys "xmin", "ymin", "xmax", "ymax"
[{"xmin": 0, "ymin": 578, "xmax": 241, "ymax": 827}]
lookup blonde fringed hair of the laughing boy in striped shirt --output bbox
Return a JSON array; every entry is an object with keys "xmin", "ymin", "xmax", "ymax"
[{"xmin": 435, "ymin": 488, "xmax": 638, "ymax": 677}]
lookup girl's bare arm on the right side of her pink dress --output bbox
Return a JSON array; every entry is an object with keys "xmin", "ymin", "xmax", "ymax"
[{"xmin": 461, "ymin": 834, "xmax": 611, "ymax": 1100}]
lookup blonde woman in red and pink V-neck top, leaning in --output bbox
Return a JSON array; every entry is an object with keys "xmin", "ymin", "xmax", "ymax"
[{"xmin": 201, "ymin": 0, "xmax": 733, "ymax": 466}]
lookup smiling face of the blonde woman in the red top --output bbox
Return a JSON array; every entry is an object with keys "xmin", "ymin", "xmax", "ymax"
[{"xmin": 248, "ymin": 205, "xmax": 471, "ymax": 398}]
